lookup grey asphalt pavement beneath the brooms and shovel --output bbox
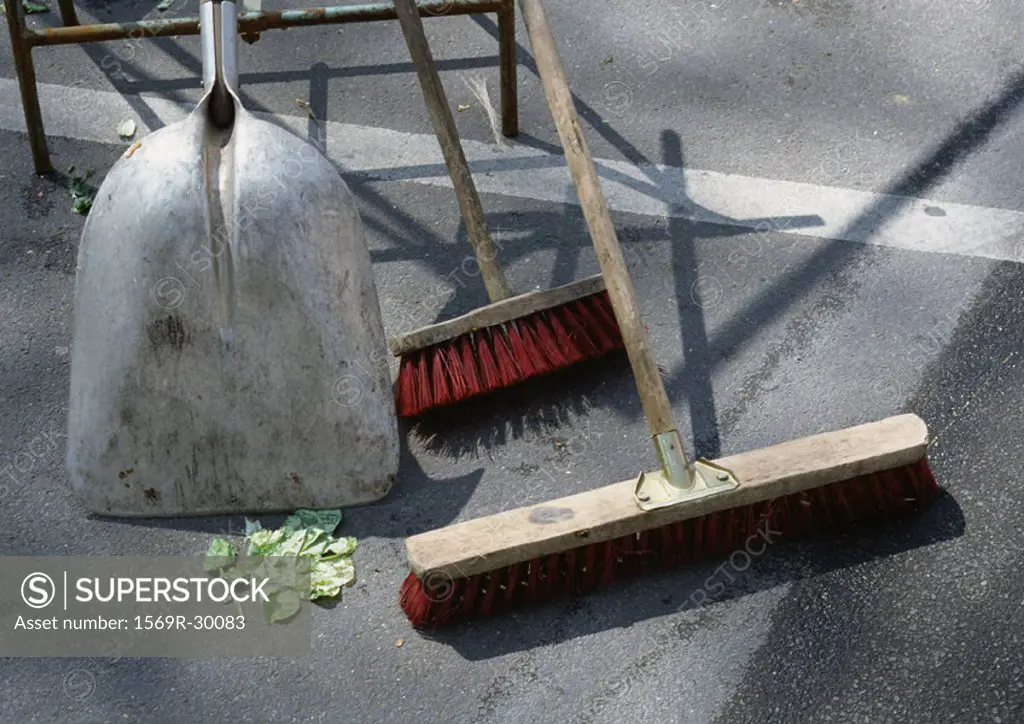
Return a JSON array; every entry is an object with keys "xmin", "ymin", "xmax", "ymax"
[{"xmin": 0, "ymin": 0, "xmax": 1024, "ymax": 724}]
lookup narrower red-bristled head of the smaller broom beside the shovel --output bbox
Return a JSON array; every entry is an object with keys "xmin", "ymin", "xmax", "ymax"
[{"xmin": 392, "ymin": 276, "xmax": 624, "ymax": 417}]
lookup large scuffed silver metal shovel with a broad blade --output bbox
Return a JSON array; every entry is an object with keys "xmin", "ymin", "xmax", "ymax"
[{"xmin": 67, "ymin": 0, "xmax": 399, "ymax": 516}]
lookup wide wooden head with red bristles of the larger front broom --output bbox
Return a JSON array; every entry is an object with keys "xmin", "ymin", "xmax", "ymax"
[{"xmin": 399, "ymin": 416, "xmax": 939, "ymax": 629}]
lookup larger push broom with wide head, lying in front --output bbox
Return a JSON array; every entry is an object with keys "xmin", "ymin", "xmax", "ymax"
[{"xmin": 399, "ymin": 0, "xmax": 938, "ymax": 629}]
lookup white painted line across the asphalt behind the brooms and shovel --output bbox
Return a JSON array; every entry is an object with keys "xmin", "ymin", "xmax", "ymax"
[{"xmin": 6, "ymin": 79, "xmax": 1024, "ymax": 261}]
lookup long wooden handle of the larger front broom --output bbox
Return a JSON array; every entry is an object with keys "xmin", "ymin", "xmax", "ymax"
[{"xmin": 519, "ymin": 0, "xmax": 676, "ymax": 435}]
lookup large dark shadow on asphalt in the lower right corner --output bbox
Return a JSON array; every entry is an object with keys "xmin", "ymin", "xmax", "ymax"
[{"xmin": 718, "ymin": 256, "xmax": 1024, "ymax": 724}]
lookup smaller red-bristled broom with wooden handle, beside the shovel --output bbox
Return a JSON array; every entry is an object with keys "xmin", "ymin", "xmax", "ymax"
[{"xmin": 389, "ymin": 0, "xmax": 623, "ymax": 417}]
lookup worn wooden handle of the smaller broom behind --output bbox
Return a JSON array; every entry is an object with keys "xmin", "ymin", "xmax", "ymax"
[{"xmin": 394, "ymin": 0, "xmax": 512, "ymax": 302}]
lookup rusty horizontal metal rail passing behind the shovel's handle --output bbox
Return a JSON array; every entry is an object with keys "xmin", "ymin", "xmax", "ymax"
[{"xmin": 25, "ymin": 0, "xmax": 504, "ymax": 47}]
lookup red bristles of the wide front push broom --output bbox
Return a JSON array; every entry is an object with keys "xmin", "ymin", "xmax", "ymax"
[{"xmin": 399, "ymin": 461, "xmax": 939, "ymax": 629}]
